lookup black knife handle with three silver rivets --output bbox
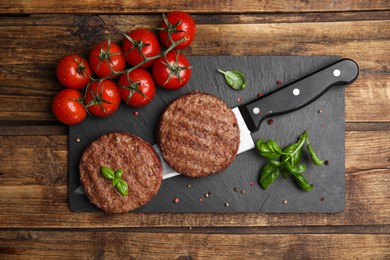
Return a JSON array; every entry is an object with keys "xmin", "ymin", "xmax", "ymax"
[{"xmin": 239, "ymin": 59, "xmax": 359, "ymax": 132}]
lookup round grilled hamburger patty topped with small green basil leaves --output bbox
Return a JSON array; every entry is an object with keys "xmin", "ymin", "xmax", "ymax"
[{"xmin": 79, "ymin": 133, "xmax": 162, "ymax": 213}]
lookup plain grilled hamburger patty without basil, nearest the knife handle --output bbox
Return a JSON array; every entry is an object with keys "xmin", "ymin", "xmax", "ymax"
[{"xmin": 157, "ymin": 92, "xmax": 240, "ymax": 177}]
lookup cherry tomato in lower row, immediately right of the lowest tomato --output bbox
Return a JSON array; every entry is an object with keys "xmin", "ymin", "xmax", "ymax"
[{"xmin": 84, "ymin": 79, "xmax": 121, "ymax": 117}]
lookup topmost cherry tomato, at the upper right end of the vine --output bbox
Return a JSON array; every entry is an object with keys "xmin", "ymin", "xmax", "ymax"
[{"xmin": 159, "ymin": 11, "xmax": 196, "ymax": 50}]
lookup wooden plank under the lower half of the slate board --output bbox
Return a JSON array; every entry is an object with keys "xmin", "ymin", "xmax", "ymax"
[{"xmin": 0, "ymin": 131, "xmax": 390, "ymax": 228}]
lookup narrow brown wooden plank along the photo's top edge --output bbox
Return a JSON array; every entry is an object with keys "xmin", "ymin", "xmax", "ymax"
[{"xmin": 0, "ymin": 0, "xmax": 390, "ymax": 14}]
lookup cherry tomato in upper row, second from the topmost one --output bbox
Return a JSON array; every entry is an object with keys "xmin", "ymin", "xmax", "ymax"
[{"xmin": 123, "ymin": 29, "xmax": 160, "ymax": 68}]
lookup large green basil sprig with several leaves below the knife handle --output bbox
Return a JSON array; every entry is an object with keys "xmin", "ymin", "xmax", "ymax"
[{"xmin": 256, "ymin": 131, "xmax": 324, "ymax": 191}]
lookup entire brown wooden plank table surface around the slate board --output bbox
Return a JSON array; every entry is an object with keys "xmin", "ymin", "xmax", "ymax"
[{"xmin": 0, "ymin": 0, "xmax": 390, "ymax": 259}]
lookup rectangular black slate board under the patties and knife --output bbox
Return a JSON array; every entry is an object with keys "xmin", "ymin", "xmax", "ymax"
[{"xmin": 69, "ymin": 56, "xmax": 345, "ymax": 213}]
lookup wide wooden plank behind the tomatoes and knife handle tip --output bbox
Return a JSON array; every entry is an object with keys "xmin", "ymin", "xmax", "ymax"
[{"xmin": 0, "ymin": 12, "xmax": 390, "ymax": 123}]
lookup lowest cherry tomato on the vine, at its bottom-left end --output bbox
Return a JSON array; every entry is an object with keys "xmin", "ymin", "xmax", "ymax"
[{"xmin": 51, "ymin": 88, "xmax": 87, "ymax": 125}]
